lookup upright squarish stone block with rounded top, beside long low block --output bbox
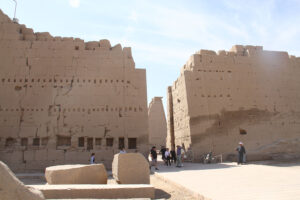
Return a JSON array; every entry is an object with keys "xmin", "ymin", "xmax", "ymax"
[{"xmin": 112, "ymin": 153, "xmax": 150, "ymax": 184}]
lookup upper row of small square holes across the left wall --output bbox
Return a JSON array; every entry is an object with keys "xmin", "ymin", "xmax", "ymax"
[{"xmin": 1, "ymin": 78, "xmax": 130, "ymax": 84}]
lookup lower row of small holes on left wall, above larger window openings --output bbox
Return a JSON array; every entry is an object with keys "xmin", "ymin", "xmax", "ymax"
[{"xmin": 0, "ymin": 107, "xmax": 143, "ymax": 112}]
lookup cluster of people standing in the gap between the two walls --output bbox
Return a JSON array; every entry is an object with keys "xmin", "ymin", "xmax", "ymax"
[{"xmin": 150, "ymin": 145, "xmax": 184, "ymax": 170}]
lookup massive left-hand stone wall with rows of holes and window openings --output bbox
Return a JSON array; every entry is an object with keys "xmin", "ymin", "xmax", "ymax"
[{"xmin": 0, "ymin": 10, "xmax": 148, "ymax": 170}]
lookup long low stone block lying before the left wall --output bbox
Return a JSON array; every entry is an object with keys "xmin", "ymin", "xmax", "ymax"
[{"xmin": 45, "ymin": 164, "xmax": 107, "ymax": 184}]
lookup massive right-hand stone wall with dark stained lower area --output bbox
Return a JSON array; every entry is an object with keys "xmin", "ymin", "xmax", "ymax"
[{"xmin": 167, "ymin": 45, "xmax": 300, "ymax": 160}]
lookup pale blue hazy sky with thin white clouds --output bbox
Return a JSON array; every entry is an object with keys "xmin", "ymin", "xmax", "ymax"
[{"xmin": 0, "ymin": 0, "xmax": 300, "ymax": 108}]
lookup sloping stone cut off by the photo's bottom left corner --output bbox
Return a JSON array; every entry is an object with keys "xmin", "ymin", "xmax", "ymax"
[{"xmin": 0, "ymin": 161, "xmax": 45, "ymax": 200}]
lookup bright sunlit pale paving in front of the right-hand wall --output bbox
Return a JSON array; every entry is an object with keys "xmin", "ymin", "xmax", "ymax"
[{"xmin": 155, "ymin": 162, "xmax": 300, "ymax": 200}]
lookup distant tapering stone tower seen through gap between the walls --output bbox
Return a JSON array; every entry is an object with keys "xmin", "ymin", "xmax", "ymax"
[{"xmin": 148, "ymin": 97, "xmax": 167, "ymax": 149}]
